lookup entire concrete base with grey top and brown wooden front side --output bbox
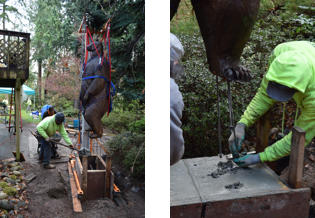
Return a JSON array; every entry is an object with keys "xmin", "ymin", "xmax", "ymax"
[{"xmin": 170, "ymin": 157, "xmax": 310, "ymax": 218}]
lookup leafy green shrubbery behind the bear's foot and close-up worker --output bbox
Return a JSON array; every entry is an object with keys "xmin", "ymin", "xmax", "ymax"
[{"xmin": 171, "ymin": 0, "xmax": 315, "ymax": 158}]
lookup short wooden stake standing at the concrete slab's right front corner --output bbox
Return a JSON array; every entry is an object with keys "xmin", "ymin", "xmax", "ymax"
[{"xmin": 288, "ymin": 126, "xmax": 305, "ymax": 188}]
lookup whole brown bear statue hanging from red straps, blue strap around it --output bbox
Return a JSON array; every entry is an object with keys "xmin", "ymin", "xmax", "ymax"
[{"xmin": 80, "ymin": 41, "xmax": 110, "ymax": 138}]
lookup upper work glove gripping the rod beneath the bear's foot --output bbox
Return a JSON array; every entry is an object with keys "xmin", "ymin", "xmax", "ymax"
[{"xmin": 229, "ymin": 123, "xmax": 245, "ymax": 157}]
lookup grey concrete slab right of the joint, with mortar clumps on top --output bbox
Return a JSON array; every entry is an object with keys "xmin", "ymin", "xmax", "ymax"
[{"xmin": 183, "ymin": 157, "xmax": 288, "ymax": 202}]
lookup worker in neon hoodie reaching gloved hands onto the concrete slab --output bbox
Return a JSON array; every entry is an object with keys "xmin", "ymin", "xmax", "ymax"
[{"xmin": 229, "ymin": 41, "xmax": 315, "ymax": 167}]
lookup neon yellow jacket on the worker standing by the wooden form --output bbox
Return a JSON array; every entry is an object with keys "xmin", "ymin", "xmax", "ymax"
[{"xmin": 36, "ymin": 115, "xmax": 72, "ymax": 145}]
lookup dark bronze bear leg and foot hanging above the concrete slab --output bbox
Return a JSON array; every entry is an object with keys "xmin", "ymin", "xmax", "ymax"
[{"xmin": 170, "ymin": 0, "xmax": 259, "ymax": 81}]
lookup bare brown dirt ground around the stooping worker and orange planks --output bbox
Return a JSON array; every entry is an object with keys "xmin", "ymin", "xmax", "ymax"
[{"xmin": 18, "ymin": 124, "xmax": 145, "ymax": 218}]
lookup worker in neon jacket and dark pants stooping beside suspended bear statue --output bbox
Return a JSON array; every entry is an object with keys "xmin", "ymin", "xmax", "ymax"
[{"xmin": 36, "ymin": 112, "xmax": 73, "ymax": 169}]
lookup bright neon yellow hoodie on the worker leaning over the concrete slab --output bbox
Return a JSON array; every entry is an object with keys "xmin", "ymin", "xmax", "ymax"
[{"xmin": 239, "ymin": 41, "xmax": 315, "ymax": 162}]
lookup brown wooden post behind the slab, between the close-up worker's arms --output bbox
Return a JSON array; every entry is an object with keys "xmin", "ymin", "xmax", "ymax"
[{"xmin": 256, "ymin": 110, "xmax": 271, "ymax": 153}]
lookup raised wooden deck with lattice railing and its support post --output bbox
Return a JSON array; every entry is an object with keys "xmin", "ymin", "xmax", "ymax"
[{"xmin": 0, "ymin": 30, "xmax": 30, "ymax": 161}]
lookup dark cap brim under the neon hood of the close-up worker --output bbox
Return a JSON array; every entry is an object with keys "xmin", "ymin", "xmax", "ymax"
[{"xmin": 267, "ymin": 81, "xmax": 297, "ymax": 102}]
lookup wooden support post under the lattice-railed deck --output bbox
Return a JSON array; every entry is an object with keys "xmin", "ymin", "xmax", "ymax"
[{"xmin": 14, "ymin": 78, "xmax": 21, "ymax": 161}]
